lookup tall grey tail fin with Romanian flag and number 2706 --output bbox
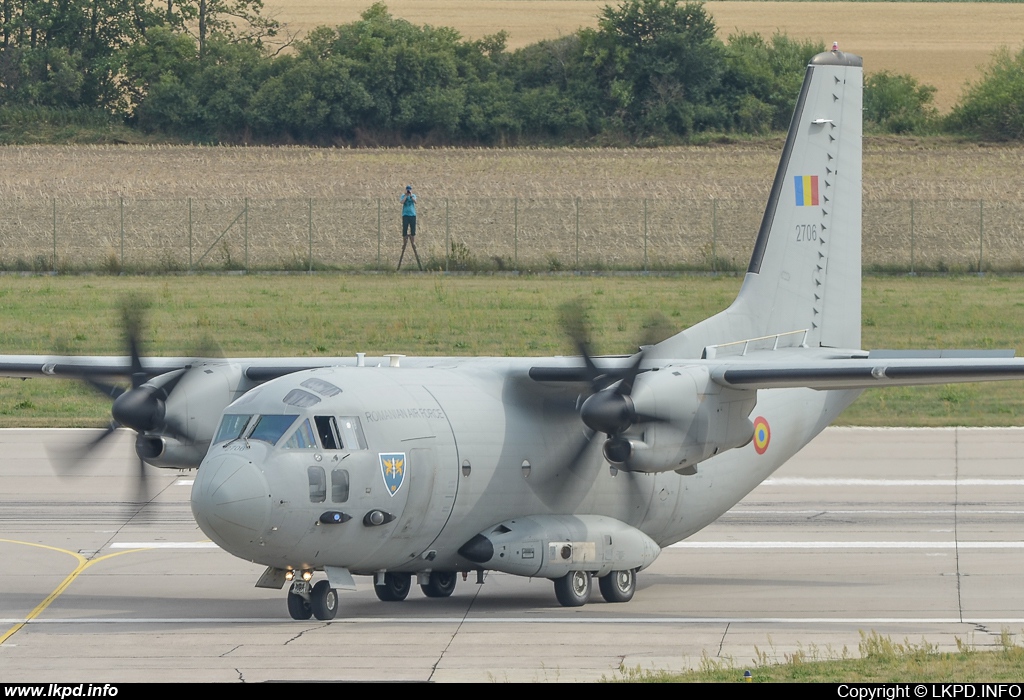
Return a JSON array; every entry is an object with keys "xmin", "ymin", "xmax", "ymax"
[{"xmin": 652, "ymin": 51, "xmax": 863, "ymax": 357}]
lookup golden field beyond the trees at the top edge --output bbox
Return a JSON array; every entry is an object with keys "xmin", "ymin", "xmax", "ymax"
[{"xmin": 266, "ymin": 0, "xmax": 1024, "ymax": 112}]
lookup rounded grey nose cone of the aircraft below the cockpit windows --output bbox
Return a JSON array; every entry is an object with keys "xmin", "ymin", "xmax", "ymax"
[{"xmin": 191, "ymin": 454, "xmax": 270, "ymax": 557}]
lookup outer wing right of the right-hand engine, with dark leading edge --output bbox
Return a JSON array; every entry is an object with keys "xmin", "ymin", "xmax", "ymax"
[{"xmin": 711, "ymin": 352, "xmax": 1024, "ymax": 390}]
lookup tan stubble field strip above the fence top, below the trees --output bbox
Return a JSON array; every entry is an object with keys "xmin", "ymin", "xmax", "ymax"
[{"xmin": 6, "ymin": 138, "xmax": 1024, "ymax": 200}]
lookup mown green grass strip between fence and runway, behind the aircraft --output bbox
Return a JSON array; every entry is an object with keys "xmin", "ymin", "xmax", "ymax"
[{"xmin": 0, "ymin": 273, "xmax": 1024, "ymax": 427}]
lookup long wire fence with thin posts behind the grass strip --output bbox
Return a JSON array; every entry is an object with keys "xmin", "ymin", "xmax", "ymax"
[{"xmin": 0, "ymin": 198, "xmax": 1024, "ymax": 273}]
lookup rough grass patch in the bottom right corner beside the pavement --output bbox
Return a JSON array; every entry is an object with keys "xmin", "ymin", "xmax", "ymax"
[{"xmin": 611, "ymin": 630, "xmax": 1024, "ymax": 683}]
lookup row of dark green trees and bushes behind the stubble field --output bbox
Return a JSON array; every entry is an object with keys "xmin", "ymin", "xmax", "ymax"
[{"xmin": 0, "ymin": 0, "xmax": 1024, "ymax": 145}]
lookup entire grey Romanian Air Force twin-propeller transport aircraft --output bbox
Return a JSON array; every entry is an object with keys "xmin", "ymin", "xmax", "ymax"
[{"xmin": 0, "ymin": 50, "xmax": 1024, "ymax": 620}]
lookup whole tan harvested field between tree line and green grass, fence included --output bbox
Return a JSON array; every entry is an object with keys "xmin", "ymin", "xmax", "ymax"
[{"xmin": 0, "ymin": 139, "xmax": 1024, "ymax": 271}]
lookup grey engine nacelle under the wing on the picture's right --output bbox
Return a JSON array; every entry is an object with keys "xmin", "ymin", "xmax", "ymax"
[{"xmin": 604, "ymin": 366, "xmax": 757, "ymax": 473}]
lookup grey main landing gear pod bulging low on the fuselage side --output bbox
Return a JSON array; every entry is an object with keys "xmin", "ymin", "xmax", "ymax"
[{"xmin": 459, "ymin": 515, "xmax": 662, "ymax": 578}]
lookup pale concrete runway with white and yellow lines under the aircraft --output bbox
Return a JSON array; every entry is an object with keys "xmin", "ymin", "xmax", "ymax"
[{"xmin": 0, "ymin": 429, "xmax": 1024, "ymax": 683}]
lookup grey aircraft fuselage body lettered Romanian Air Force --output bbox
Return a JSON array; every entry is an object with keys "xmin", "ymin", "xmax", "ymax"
[{"xmin": 193, "ymin": 359, "xmax": 857, "ymax": 573}]
